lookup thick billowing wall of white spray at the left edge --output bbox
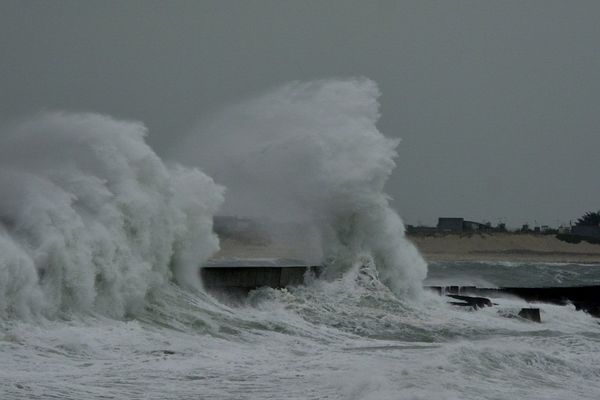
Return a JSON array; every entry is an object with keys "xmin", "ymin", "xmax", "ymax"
[{"xmin": 0, "ymin": 113, "xmax": 223, "ymax": 317}]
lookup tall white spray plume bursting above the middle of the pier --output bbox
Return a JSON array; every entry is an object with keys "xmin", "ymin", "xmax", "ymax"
[{"xmin": 174, "ymin": 79, "xmax": 427, "ymax": 295}]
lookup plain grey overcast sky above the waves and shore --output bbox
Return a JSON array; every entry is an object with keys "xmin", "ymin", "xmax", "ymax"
[{"xmin": 0, "ymin": 0, "xmax": 600, "ymax": 225}]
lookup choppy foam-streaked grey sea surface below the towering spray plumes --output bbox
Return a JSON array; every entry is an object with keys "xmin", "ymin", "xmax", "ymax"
[{"xmin": 0, "ymin": 262, "xmax": 600, "ymax": 400}]
